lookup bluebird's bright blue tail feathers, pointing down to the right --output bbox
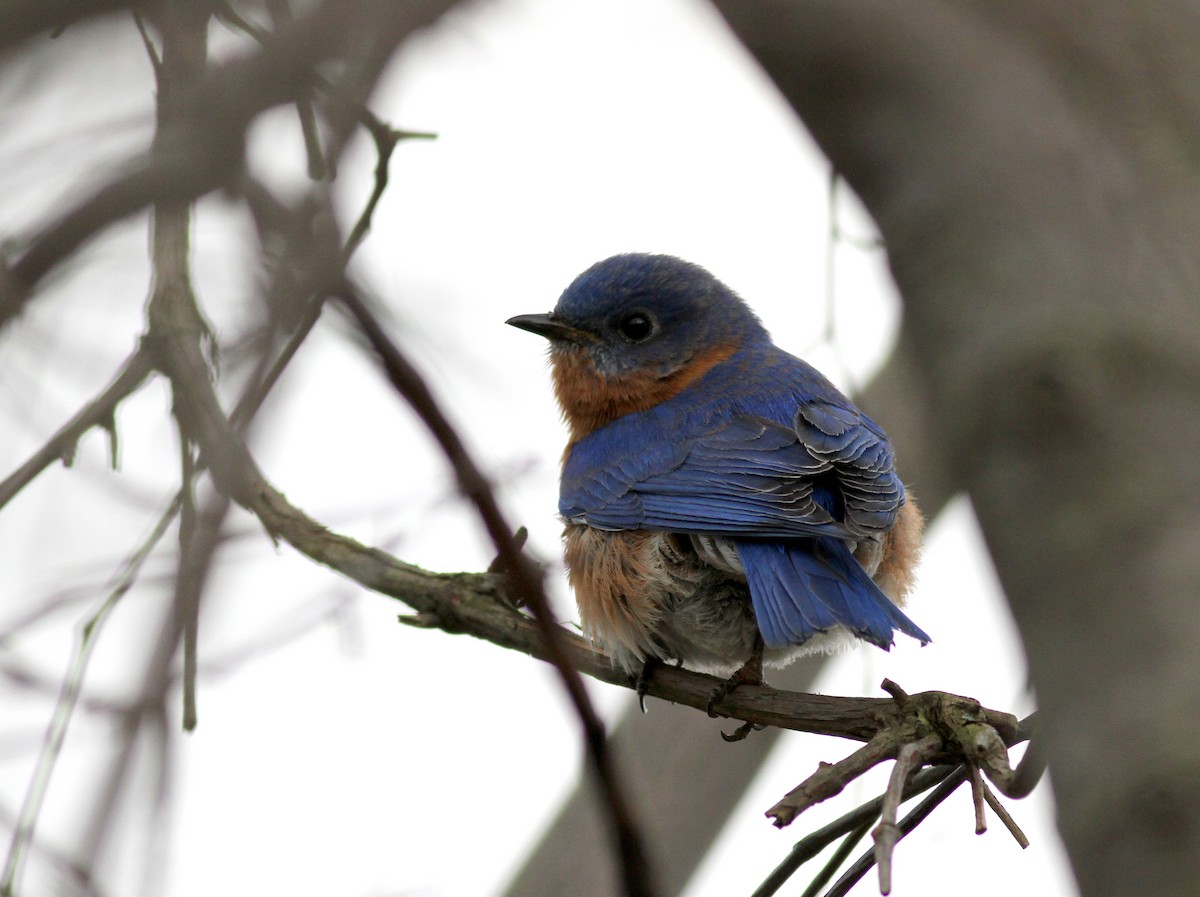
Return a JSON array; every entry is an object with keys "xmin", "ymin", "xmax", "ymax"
[{"xmin": 736, "ymin": 538, "xmax": 930, "ymax": 650}]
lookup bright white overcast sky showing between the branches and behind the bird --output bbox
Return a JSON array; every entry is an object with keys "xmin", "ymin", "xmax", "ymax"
[{"xmin": 0, "ymin": 0, "xmax": 1074, "ymax": 897}]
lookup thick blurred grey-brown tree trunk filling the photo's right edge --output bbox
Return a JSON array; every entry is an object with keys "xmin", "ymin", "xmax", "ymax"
[{"xmin": 718, "ymin": 0, "xmax": 1200, "ymax": 897}]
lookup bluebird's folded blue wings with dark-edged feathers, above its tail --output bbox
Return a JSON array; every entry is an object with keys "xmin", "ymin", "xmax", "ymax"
[{"xmin": 559, "ymin": 401, "xmax": 904, "ymax": 540}]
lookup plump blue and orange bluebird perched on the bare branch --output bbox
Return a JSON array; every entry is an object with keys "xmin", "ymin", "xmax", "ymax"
[{"xmin": 508, "ymin": 254, "xmax": 929, "ymax": 681}]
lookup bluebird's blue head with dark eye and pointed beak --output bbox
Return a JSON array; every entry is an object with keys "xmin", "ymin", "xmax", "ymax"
[{"xmin": 508, "ymin": 253, "xmax": 767, "ymax": 379}]
